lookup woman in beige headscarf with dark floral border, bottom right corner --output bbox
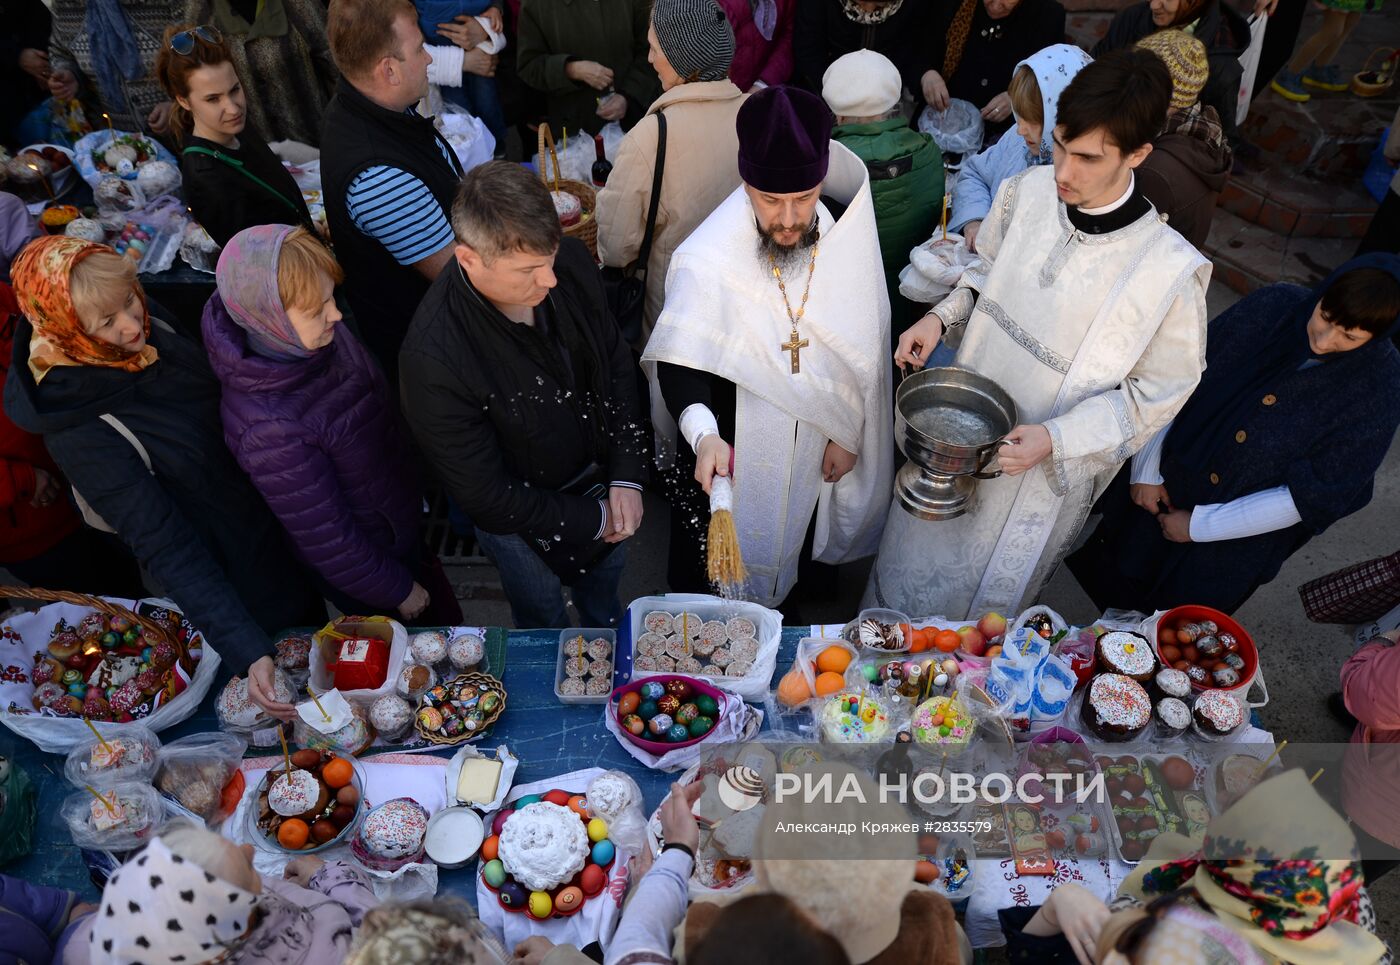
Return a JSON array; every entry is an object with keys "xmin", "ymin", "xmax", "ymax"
[{"xmin": 1000, "ymin": 769, "xmax": 1387, "ymax": 965}]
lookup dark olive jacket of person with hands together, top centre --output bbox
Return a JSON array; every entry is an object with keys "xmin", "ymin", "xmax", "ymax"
[{"xmin": 515, "ymin": 0, "xmax": 661, "ymax": 139}]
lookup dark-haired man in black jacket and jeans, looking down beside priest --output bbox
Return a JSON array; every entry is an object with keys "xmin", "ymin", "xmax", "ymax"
[{"xmin": 399, "ymin": 161, "xmax": 645, "ymax": 626}]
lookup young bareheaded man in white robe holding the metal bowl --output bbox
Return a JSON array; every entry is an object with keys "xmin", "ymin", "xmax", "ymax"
[{"xmin": 865, "ymin": 50, "xmax": 1211, "ymax": 619}]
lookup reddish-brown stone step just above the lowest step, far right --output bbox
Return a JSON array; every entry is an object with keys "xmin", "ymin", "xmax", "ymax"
[{"xmin": 1219, "ymin": 162, "xmax": 1378, "ymax": 238}]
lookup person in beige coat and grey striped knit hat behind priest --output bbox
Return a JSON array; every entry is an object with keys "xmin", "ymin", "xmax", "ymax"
[{"xmin": 598, "ymin": 0, "xmax": 745, "ymax": 350}]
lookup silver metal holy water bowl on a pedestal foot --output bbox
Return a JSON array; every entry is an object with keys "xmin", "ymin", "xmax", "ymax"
[{"xmin": 895, "ymin": 366, "xmax": 1016, "ymax": 521}]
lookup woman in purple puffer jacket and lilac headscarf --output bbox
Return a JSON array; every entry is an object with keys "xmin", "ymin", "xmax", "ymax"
[{"xmin": 203, "ymin": 224, "xmax": 462, "ymax": 626}]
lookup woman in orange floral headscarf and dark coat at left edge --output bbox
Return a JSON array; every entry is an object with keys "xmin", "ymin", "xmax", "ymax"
[{"xmin": 4, "ymin": 235, "xmax": 326, "ymax": 717}]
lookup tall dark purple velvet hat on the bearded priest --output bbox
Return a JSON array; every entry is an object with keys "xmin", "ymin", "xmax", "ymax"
[{"xmin": 736, "ymin": 85, "xmax": 834, "ymax": 195}]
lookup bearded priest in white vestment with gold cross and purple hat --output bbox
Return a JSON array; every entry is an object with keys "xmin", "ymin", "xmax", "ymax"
[{"xmin": 641, "ymin": 87, "xmax": 893, "ymax": 606}]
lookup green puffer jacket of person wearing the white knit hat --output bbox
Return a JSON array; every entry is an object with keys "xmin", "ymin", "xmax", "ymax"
[{"xmin": 832, "ymin": 118, "xmax": 944, "ymax": 338}]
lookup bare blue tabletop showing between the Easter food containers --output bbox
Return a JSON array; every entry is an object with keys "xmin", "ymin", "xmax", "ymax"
[{"xmin": 0, "ymin": 627, "xmax": 806, "ymax": 902}]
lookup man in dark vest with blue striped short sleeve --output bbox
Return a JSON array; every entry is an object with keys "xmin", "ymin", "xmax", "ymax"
[{"xmin": 321, "ymin": 0, "xmax": 462, "ymax": 381}]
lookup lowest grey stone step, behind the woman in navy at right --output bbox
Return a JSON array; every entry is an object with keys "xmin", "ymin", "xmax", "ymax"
[{"xmin": 1203, "ymin": 209, "xmax": 1357, "ymax": 294}]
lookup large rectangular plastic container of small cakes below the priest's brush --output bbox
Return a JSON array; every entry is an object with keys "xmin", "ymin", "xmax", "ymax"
[{"xmin": 622, "ymin": 594, "xmax": 783, "ymax": 703}]
